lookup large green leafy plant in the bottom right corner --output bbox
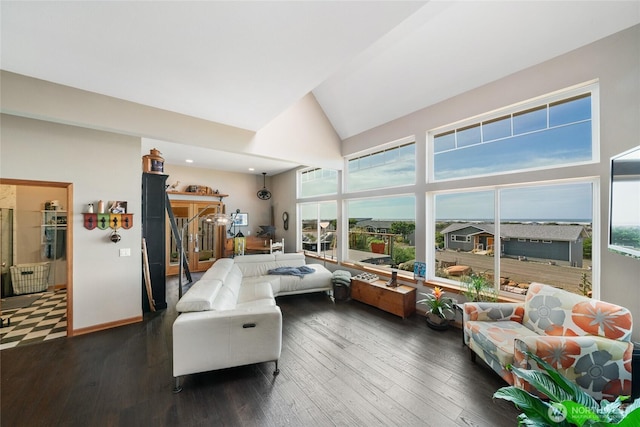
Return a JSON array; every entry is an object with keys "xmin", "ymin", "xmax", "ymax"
[{"xmin": 493, "ymin": 352, "xmax": 640, "ymax": 427}]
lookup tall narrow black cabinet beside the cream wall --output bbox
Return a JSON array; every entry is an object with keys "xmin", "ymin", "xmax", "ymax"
[{"xmin": 142, "ymin": 173, "xmax": 168, "ymax": 311}]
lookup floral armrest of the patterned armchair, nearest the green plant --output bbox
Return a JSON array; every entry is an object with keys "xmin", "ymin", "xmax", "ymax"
[{"xmin": 513, "ymin": 335, "xmax": 633, "ymax": 400}]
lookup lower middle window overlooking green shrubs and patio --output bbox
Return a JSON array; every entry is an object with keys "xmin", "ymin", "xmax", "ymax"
[{"xmin": 346, "ymin": 195, "xmax": 416, "ymax": 271}]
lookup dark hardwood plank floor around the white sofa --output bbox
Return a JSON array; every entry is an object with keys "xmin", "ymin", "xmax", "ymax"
[{"xmin": 0, "ymin": 274, "xmax": 519, "ymax": 427}]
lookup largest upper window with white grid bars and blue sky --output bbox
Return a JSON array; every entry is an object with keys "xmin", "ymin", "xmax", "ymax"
[{"xmin": 433, "ymin": 86, "xmax": 597, "ymax": 181}]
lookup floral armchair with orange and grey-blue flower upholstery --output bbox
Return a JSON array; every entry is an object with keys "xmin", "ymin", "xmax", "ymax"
[{"xmin": 463, "ymin": 283, "xmax": 633, "ymax": 400}]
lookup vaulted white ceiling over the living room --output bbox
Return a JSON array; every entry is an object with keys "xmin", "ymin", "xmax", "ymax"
[{"xmin": 0, "ymin": 0, "xmax": 640, "ymax": 172}]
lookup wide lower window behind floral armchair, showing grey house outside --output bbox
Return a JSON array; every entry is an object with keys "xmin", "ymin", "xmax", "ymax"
[{"xmin": 434, "ymin": 181, "xmax": 594, "ymax": 295}]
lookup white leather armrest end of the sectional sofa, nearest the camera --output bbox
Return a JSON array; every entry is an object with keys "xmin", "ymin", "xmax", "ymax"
[{"xmin": 173, "ymin": 305, "xmax": 282, "ymax": 377}]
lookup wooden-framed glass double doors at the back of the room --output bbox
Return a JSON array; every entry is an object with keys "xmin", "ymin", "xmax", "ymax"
[{"xmin": 166, "ymin": 200, "xmax": 227, "ymax": 275}]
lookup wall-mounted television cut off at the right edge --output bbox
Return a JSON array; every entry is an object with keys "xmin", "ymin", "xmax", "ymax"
[{"xmin": 609, "ymin": 146, "xmax": 640, "ymax": 259}]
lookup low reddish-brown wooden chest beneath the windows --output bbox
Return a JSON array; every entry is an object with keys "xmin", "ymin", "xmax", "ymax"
[{"xmin": 351, "ymin": 279, "xmax": 416, "ymax": 319}]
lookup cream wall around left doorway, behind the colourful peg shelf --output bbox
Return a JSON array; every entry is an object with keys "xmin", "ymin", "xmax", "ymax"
[{"xmin": 0, "ymin": 115, "xmax": 142, "ymax": 330}]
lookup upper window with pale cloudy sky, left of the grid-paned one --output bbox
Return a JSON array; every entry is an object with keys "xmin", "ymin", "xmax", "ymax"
[{"xmin": 346, "ymin": 142, "xmax": 416, "ymax": 192}]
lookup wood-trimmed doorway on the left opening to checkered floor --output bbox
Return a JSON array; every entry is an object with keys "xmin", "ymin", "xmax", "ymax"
[{"xmin": 0, "ymin": 178, "xmax": 73, "ymax": 348}]
